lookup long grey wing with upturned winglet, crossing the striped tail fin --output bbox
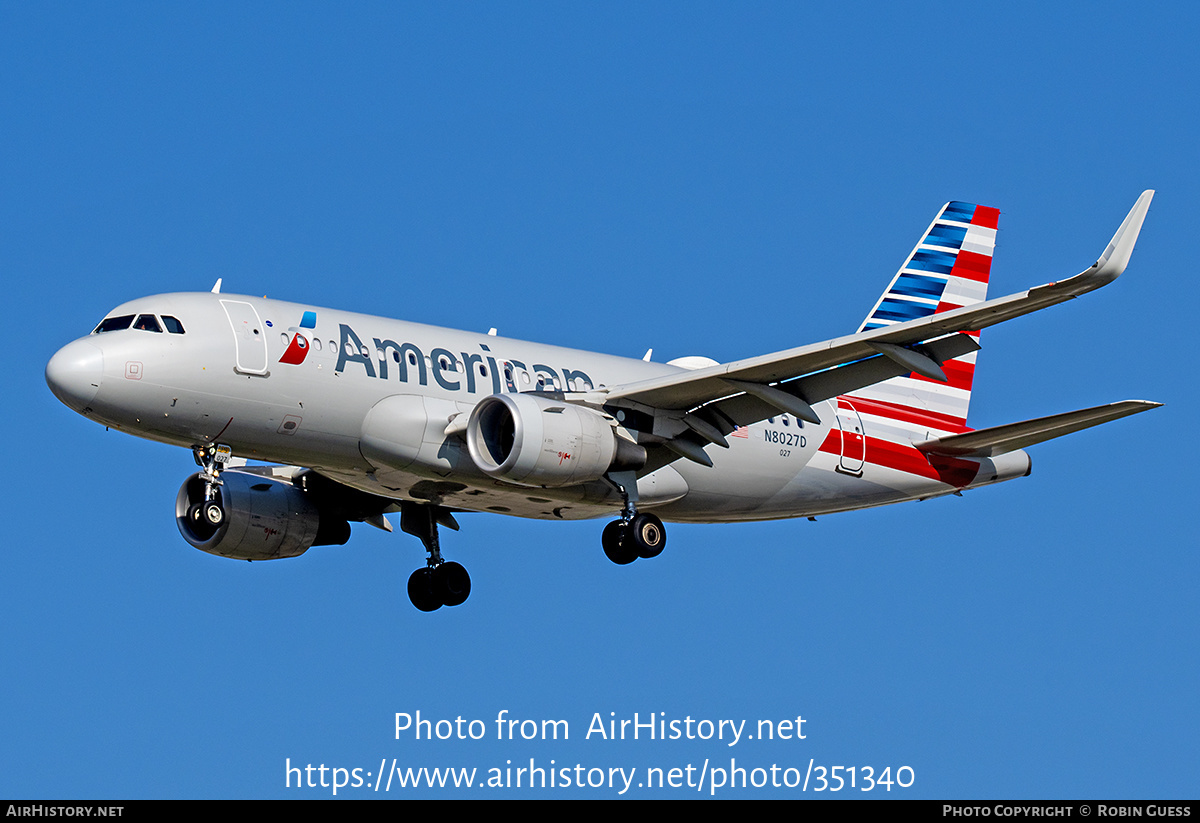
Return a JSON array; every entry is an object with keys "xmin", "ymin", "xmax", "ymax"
[{"xmin": 604, "ymin": 190, "xmax": 1154, "ymax": 463}]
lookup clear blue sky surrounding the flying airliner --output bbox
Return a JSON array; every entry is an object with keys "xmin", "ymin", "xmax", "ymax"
[{"xmin": 0, "ymin": 4, "xmax": 1200, "ymax": 798}]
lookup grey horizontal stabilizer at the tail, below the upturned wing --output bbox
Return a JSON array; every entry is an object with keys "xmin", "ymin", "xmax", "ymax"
[{"xmin": 916, "ymin": 400, "xmax": 1162, "ymax": 457}]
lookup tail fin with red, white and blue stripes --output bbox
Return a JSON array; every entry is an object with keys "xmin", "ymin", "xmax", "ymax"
[{"xmin": 851, "ymin": 202, "xmax": 1000, "ymax": 433}]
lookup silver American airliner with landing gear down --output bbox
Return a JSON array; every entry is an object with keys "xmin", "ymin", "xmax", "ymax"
[{"xmin": 46, "ymin": 190, "xmax": 1160, "ymax": 612}]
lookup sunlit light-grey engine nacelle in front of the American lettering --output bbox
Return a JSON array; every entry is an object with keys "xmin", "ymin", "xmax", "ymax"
[{"xmin": 467, "ymin": 395, "xmax": 646, "ymax": 487}]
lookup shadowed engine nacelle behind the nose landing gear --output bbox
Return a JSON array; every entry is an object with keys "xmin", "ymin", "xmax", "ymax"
[{"xmin": 175, "ymin": 469, "xmax": 350, "ymax": 560}]
